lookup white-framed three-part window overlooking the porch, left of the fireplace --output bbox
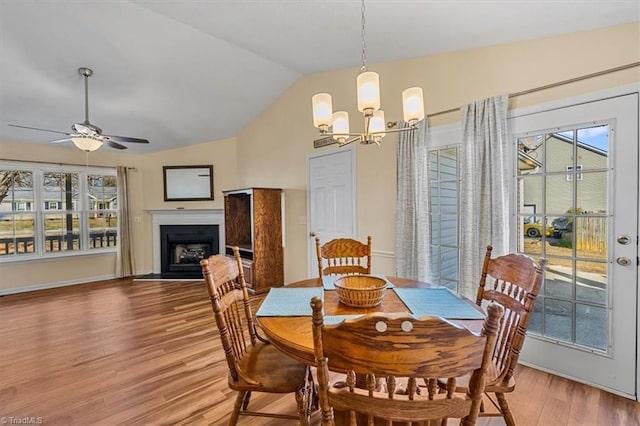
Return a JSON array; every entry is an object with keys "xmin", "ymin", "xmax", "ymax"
[{"xmin": 0, "ymin": 163, "xmax": 118, "ymax": 260}]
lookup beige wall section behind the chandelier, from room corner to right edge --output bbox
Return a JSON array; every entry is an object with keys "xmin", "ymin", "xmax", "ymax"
[{"xmin": 238, "ymin": 24, "xmax": 640, "ymax": 282}]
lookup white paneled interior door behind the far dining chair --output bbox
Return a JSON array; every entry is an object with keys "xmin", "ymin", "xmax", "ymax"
[{"xmin": 307, "ymin": 148, "xmax": 356, "ymax": 277}]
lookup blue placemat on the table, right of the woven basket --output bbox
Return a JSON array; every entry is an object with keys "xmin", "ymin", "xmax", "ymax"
[{"xmin": 393, "ymin": 287, "xmax": 484, "ymax": 319}]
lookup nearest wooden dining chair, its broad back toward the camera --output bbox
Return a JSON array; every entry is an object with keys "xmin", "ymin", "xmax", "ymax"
[{"xmin": 311, "ymin": 297, "xmax": 502, "ymax": 426}]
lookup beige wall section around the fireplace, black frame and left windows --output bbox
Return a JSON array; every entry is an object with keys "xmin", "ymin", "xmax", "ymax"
[{"xmin": 0, "ymin": 138, "xmax": 238, "ymax": 293}]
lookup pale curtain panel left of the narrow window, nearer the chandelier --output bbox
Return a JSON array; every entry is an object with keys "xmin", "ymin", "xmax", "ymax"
[{"xmin": 396, "ymin": 120, "xmax": 431, "ymax": 281}]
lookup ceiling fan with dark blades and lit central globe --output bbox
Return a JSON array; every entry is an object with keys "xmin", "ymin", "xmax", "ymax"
[{"xmin": 9, "ymin": 67, "xmax": 149, "ymax": 152}]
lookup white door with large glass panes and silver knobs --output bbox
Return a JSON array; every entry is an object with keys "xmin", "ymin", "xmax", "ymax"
[{"xmin": 510, "ymin": 92, "xmax": 639, "ymax": 399}]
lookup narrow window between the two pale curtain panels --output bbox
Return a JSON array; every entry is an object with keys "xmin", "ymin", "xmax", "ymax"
[{"xmin": 429, "ymin": 146, "xmax": 460, "ymax": 292}]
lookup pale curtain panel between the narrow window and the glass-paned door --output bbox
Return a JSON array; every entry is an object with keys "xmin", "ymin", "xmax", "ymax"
[{"xmin": 459, "ymin": 95, "xmax": 513, "ymax": 298}]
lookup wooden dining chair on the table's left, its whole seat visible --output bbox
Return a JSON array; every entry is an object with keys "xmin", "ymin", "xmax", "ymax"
[{"xmin": 200, "ymin": 247, "xmax": 315, "ymax": 425}]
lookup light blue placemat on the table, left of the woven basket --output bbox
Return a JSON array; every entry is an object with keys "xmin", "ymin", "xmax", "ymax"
[{"xmin": 256, "ymin": 287, "xmax": 324, "ymax": 317}]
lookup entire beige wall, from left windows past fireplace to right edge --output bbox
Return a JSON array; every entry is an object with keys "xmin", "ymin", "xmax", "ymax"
[{"xmin": 0, "ymin": 24, "xmax": 640, "ymax": 290}]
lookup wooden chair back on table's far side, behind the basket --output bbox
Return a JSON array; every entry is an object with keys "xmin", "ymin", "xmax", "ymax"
[{"xmin": 316, "ymin": 236, "xmax": 371, "ymax": 278}]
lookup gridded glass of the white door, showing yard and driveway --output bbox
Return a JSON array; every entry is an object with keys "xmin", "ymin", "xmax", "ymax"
[{"xmin": 515, "ymin": 124, "xmax": 610, "ymax": 352}]
